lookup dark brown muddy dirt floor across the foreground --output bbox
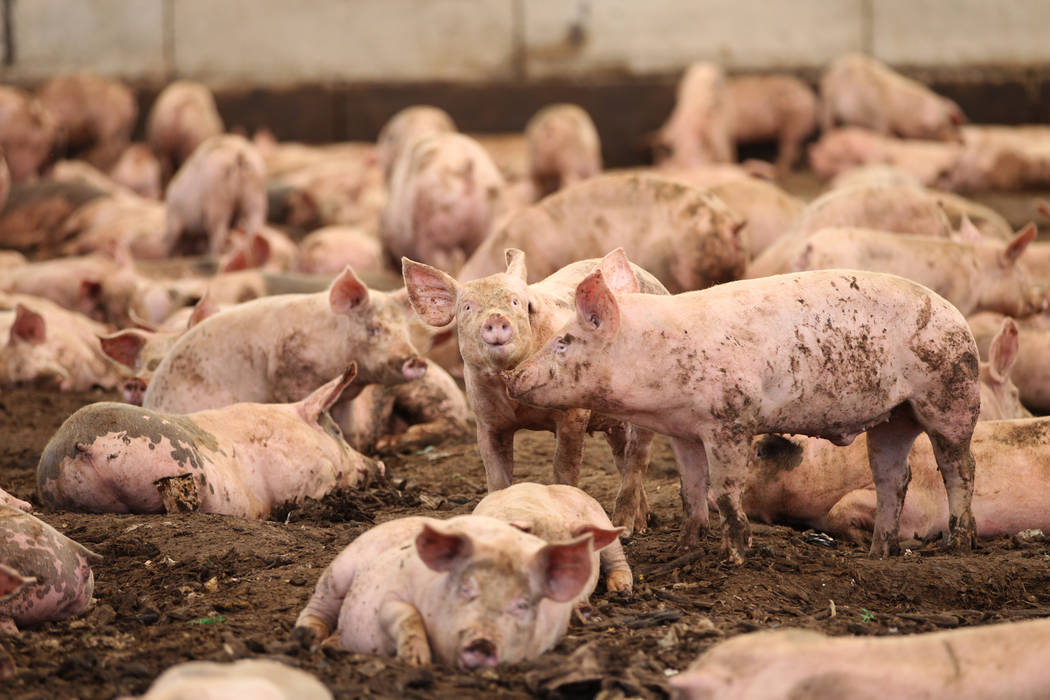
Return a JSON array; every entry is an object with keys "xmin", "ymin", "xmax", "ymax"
[{"xmin": 0, "ymin": 390, "xmax": 1050, "ymax": 699}]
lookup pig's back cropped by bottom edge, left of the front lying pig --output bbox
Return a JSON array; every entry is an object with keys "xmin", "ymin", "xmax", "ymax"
[{"xmin": 121, "ymin": 659, "xmax": 332, "ymax": 700}]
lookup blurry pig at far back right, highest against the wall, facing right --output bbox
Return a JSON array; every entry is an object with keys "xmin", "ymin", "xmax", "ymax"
[{"xmin": 820, "ymin": 54, "xmax": 966, "ymax": 141}]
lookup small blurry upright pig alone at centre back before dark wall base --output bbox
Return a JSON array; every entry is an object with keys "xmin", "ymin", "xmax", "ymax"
[{"xmin": 525, "ymin": 104, "xmax": 602, "ymax": 197}]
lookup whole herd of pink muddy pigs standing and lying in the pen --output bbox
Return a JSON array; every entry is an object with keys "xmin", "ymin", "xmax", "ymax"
[{"xmin": 0, "ymin": 51, "xmax": 1050, "ymax": 698}]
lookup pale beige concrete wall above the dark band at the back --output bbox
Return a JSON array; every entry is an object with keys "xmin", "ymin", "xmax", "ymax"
[{"xmin": 6, "ymin": 0, "xmax": 1050, "ymax": 88}]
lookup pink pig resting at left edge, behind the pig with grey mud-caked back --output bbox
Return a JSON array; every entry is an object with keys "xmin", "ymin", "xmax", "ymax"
[{"xmin": 0, "ymin": 294, "xmax": 123, "ymax": 391}]
